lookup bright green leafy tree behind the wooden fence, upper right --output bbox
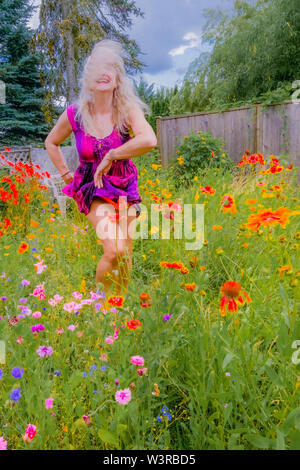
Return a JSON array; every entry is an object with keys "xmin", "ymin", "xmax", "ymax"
[{"xmin": 204, "ymin": 0, "xmax": 300, "ymax": 107}]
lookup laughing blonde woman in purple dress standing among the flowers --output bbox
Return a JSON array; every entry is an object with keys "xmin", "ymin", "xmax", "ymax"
[{"xmin": 45, "ymin": 39, "xmax": 157, "ymax": 295}]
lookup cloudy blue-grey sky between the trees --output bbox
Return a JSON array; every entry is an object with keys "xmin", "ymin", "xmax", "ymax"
[{"xmin": 29, "ymin": 0, "xmax": 234, "ymax": 89}]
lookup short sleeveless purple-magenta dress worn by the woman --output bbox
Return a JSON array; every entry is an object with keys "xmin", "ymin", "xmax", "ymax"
[{"xmin": 62, "ymin": 103, "xmax": 142, "ymax": 217}]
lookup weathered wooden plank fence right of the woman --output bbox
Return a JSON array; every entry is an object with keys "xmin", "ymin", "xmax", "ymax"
[{"xmin": 156, "ymin": 101, "xmax": 300, "ymax": 171}]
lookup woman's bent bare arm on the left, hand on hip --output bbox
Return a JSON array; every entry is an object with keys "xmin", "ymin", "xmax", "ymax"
[{"xmin": 45, "ymin": 110, "xmax": 72, "ymax": 177}]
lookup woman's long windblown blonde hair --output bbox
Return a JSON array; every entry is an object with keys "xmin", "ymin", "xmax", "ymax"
[{"xmin": 75, "ymin": 39, "xmax": 150, "ymax": 138}]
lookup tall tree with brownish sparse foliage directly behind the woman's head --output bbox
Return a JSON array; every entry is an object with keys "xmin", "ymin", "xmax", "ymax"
[{"xmin": 31, "ymin": 0, "xmax": 144, "ymax": 125}]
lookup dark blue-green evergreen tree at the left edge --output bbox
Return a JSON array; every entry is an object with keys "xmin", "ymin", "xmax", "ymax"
[{"xmin": 0, "ymin": 0, "xmax": 49, "ymax": 146}]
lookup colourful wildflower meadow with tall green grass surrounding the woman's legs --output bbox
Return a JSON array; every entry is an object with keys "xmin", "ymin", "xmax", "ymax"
[{"xmin": 0, "ymin": 145, "xmax": 300, "ymax": 450}]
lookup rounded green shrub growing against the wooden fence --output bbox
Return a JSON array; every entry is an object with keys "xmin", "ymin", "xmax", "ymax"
[{"xmin": 170, "ymin": 131, "xmax": 234, "ymax": 184}]
